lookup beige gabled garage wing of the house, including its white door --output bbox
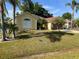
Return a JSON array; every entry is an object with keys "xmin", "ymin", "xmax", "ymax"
[{"xmin": 16, "ymin": 12, "xmax": 42, "ymax": 31}]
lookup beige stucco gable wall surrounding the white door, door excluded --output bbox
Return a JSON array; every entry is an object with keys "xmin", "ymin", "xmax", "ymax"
[{"xmin": 16, "ymin": 12, "xmax": 38, "ymax": 31}]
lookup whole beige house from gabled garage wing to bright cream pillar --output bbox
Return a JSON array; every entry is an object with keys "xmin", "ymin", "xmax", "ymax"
[{"xmin": 16, "ymin": 12, "xmax": 57, "ymax": 31}]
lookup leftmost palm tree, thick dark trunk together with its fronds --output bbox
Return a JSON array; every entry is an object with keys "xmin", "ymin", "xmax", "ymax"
[{"xmin": 0, "ymin": 0, "xmax": 6, "ymax": 41}]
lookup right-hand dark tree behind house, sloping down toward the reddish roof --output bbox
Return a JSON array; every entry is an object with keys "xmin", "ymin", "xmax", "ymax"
[{"xmin": 33, "ymin": 2, "xmax": 52, "ymax": 18}]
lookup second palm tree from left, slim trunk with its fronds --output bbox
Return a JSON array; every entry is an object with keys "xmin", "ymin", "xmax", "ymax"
[{"xmin": 8, "ymin": 0, "xmax": 20, "ymax": 38}]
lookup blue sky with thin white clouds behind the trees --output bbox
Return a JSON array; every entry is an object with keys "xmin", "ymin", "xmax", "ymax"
[{"xmin": 6, "ymin": 0, "xmax": 79, "ymax": 18}]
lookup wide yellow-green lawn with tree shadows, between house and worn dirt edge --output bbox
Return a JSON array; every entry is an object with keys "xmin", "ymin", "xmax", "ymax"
[{"xmin": 0, "ymin": 32, "xmax": 79, "ymax": 59}]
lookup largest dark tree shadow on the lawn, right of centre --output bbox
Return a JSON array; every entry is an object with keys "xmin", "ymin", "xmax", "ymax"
[{"xmin": 45, "ymin": 31, "xmax": 74, "ymax": 42}]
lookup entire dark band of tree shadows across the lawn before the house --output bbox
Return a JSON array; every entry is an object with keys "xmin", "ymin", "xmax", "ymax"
[{"xmin": 16, "ymin": 31, "xmax": 74, "ymax": 42}]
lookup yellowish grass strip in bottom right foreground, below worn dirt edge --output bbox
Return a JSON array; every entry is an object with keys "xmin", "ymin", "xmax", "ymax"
[{"xmin": 24, "ymin": 50, "xmax": 79, "ymax": 59}]
